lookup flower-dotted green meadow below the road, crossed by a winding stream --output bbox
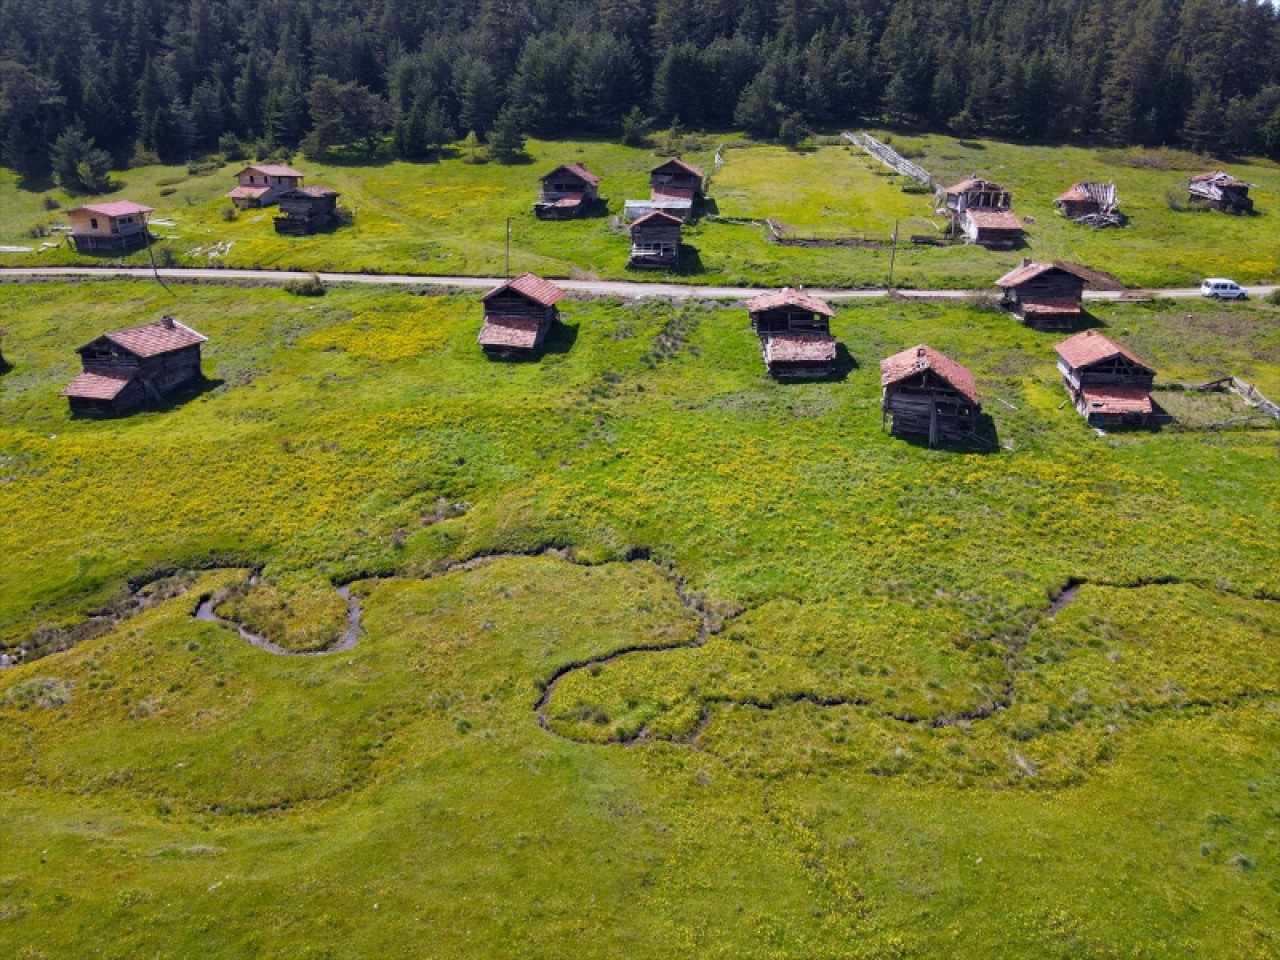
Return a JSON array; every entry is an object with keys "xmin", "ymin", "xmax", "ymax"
[{"xmin": 0, "ymin": 276, "xmax": 1280, "ymax": 960}]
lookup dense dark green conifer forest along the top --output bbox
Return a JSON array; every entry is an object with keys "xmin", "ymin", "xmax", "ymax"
[{"xmin": 0, "ymin": 0, "xmax": 1280, "ymax": 187}]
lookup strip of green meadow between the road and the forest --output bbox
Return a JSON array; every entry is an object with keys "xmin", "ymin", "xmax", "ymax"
[{"xmin": 0, "ymin": 132, "xmax": 1280, "ymax": 288}]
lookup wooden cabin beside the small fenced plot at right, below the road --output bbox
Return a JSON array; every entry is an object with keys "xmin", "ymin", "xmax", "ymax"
[{"xmin": 1053, "ymin": 330, "xmax": 1156, "ymax": 426}]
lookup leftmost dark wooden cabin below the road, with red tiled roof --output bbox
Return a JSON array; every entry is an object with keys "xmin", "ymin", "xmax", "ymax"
[{"xmin": 61, "ymin": 316, "xmax": 209, "ymax": 416}]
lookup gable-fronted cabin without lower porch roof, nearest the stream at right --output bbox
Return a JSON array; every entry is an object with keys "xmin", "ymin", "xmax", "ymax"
[{"xmin": 881, "ymin": 343, "xmax": 982, "ymax": 447}]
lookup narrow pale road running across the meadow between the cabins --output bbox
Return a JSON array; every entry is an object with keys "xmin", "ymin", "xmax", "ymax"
[{"xmin": 0, "ymin": 266, "xmax": 1277, "ymax": 301}]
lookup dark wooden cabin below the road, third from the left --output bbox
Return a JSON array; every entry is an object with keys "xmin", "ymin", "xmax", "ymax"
[{"xmin": 746, "ymin": 287, "xmax": 836, "ymax": 379}]
